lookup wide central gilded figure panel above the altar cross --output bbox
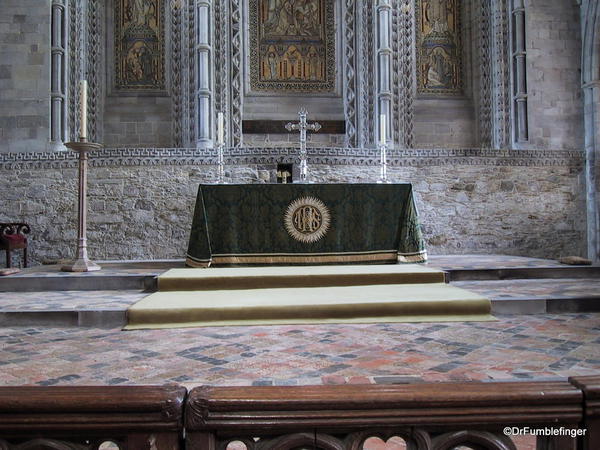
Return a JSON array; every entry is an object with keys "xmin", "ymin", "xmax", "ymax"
[{"xmin": 250, "ymin": 0, "xmax": 335, "ymax": 92}]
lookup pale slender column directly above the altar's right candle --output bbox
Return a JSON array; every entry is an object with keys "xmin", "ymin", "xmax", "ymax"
[{"xmin": 375, "ymin": 0, "xmax": 392, "ymax": 142}]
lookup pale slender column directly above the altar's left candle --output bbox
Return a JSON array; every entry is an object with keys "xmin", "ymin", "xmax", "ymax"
[{"xmin": 195, "ymin": 0, "xmax": 214, "ymax": 148}]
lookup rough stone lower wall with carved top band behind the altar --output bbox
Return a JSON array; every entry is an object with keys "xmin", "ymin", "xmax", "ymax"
[{"xmin": 0, "ymin": 148, "xmax": 585, "ymax": 263}]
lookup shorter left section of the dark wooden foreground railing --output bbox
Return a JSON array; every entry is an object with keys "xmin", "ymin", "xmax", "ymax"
[{"xmin": 0, "ymin": 385, "xmax": 186, "ymax": 450}]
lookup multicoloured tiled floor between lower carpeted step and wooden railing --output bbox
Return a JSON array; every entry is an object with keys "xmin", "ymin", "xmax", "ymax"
[{"xmin": 0, "ymin": 314, "xmax": 600, "ymax": 386}]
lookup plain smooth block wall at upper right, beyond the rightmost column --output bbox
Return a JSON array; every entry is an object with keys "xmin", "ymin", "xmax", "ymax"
[{"xmin": 525, "ymin": 0, "xmax": 584, "ymax": 149}]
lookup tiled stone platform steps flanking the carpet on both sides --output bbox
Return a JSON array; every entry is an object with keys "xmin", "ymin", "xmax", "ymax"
[{"xmin": 0, "ymin": 255, "xmax": 600, "ymax": 328}]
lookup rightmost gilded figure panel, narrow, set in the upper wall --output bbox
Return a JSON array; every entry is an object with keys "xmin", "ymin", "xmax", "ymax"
[{"xmin": 417, "ymin": 0, "xmax": 462, "ymax": 94}]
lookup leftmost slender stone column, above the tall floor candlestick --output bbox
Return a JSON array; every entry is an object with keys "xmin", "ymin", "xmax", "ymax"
[{"xmin": 49, "ymin": 0, "xmax": 69, "ymax": 151}]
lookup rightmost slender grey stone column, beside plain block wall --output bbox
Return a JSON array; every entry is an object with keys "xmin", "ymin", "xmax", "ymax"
[{"xmin": 511, "ymin": 0, "xmax": 529, "ymax": 144}]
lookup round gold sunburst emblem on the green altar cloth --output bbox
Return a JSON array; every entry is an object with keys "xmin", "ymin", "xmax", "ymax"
[{"xmin": 283, "ymin": 197, "xmax": 331, "ymax": 244}]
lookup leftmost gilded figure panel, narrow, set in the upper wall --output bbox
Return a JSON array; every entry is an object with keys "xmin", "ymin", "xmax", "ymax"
[{"xmin": 115, "ymin": 0, "xmax": 165, "ymax": 91}]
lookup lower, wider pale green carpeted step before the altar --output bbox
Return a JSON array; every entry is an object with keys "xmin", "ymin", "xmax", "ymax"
[{"xmin": 126, "ymin": 283, "xmax": 493, "ymax": 329}]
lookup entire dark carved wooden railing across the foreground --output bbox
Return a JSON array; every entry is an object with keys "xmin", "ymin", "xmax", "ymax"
[{"xmin": 0, "ymin": 376, "xmax": 600, "ymax": 450}]
